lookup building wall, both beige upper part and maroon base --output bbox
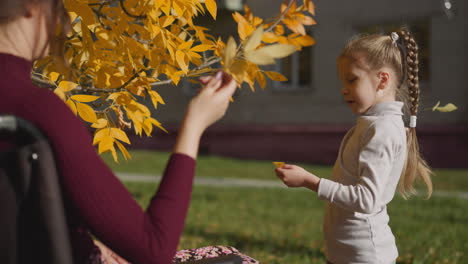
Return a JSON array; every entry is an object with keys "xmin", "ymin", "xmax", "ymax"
[{"xmin": 138, "ymin": 0, "xmax": 468, "ymax": 167}]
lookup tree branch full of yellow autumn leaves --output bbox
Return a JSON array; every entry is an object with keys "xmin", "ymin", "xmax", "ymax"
[{"xmin": 32, "ymin": 0, "xmax": 315, "ymax": 161}]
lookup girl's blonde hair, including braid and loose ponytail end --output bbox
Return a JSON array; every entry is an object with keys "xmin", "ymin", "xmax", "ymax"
[{"xmin": 339, "ymin": 29, "xmax": 433, "ymax": 199}]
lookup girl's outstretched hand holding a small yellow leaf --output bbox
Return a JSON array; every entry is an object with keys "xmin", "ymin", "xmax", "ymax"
[{"xmin": 275, "ymin": 164, "xmax": 320, "ymax": 191}]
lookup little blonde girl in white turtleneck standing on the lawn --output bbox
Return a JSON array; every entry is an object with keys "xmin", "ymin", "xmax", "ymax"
[{"xmin": 275, "ymin": 30, "xmax": 432, "ymax": 264}]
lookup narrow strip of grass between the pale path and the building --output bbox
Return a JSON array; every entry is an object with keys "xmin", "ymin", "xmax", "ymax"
[{"xmin": 103, "ymin": 150, "xmax": 468, "ymax": 191}]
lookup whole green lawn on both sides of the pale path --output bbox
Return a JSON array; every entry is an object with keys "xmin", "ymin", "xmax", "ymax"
[{"xmin": 104, "ymin": 151, "xmax": 468, "ymax": 264}]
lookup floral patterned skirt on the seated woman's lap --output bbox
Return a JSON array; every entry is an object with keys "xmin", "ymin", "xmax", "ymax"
[{"xmin": 172, "ymin": 246, "xmax": 260, "ymax": 264}]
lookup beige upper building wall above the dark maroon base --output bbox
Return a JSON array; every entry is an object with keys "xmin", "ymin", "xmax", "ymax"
[{"xmin": 152, "ymin": 0, "xmax": 468, "ymax": 124}]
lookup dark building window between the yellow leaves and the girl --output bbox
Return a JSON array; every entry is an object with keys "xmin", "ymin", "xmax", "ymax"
[{"xmin": 273, "ymin": 32, "xmax": 314, "ymax": 91}]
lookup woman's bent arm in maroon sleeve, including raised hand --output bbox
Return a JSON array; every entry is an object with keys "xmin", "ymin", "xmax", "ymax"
[{"xmin": 28, "ymin": 71, "xmax": 236, "ymax": 264}]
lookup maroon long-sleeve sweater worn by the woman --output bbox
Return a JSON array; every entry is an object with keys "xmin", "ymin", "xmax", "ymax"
[{"xmin": 0, "ymin": 53, "xmax": 195, "ymax": 264}]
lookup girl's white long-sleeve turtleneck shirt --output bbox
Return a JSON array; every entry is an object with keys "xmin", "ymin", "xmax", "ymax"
[{"xmin": 318, "ymin": 101, "xmax": 407, "ymax": 264}]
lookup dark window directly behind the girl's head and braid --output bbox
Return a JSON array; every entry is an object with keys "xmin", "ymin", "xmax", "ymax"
[{"xmin": 356, "ymin": 19, "xmax": 431, "ymax": 82}]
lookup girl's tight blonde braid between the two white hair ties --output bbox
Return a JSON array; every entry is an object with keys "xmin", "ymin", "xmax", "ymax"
[{"xmin": 399, "ymin": 30, "xmax": 419, "ymax": 115}]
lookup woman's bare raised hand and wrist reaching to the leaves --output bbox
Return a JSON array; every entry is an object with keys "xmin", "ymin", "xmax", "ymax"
[{"xmin": 174, "ymin": 71, "xmax": 237, "ymax": 158}]
